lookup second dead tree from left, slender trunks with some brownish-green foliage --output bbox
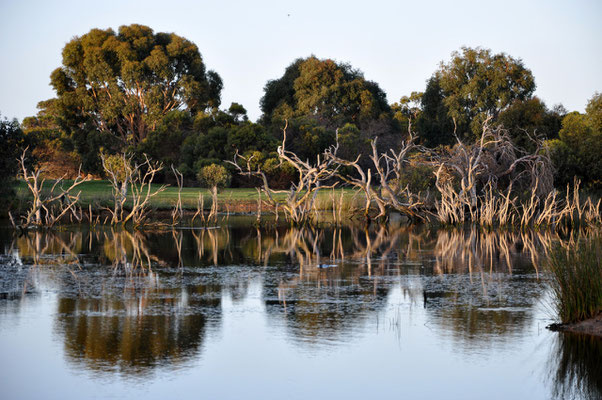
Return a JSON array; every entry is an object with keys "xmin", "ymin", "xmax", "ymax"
[{"xmin": 101, "ymin": 154, "xmax": 166, "ymax": 227}]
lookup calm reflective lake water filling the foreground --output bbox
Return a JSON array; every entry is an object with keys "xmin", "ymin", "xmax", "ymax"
[{"xmin": 0, "ymin": 220, "xmax": 602, "ymax": 399}]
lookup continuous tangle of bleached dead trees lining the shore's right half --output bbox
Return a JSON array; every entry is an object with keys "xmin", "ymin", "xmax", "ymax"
[{"xmin": 230, "ymin": 119, "xmax": 602, "ymax": 227}]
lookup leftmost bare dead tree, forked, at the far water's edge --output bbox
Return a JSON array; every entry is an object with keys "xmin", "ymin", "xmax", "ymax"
[{"xmin": 9, "ymin": 149, "xmax": 89, "ymax": 229}]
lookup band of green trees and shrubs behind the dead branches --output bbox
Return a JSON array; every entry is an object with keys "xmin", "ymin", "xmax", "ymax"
[{"xmin": 0, "ymin": 25, "xmax": 602, "ymax": 195}]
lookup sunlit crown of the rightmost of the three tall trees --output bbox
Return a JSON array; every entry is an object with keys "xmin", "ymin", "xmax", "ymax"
[{"xmin": 432, "ymin": 47, "xmax": 535, "ymax": 138}]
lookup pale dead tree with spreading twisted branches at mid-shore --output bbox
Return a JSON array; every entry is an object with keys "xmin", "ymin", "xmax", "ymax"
[{"xmin": 228, "ymin": 121, "xmax": 339, "ymax": 225}]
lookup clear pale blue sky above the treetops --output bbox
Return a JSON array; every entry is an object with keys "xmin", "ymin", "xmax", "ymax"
[{"xmin": 0, "ymin": 0, "xmax": 602, "ymax": 121}]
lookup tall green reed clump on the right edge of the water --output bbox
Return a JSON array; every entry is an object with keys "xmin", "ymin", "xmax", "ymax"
[{"xmin": 548, "ymin": 237, "xmax": 602, "ymax": 323}]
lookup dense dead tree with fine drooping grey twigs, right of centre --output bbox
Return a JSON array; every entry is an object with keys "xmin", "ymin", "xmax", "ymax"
[{"xmin": 431, "ymin": 118, "xmax": 555, "ymax": 225}]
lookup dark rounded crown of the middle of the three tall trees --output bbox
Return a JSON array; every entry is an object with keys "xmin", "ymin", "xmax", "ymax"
[{"xmin": 261, "ymin": 56, "xmax": 400, "ymax": 159}]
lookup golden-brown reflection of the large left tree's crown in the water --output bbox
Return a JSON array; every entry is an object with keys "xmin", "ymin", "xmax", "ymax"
[{"xmin": 57, "ymin": 291, "xmax": 213, "ymax": 374}]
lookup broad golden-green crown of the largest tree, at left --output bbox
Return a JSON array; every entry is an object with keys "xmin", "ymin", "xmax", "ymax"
[{"xmin": 51, "ymin": 25, "xmax": 222, "ymax": 146}]
